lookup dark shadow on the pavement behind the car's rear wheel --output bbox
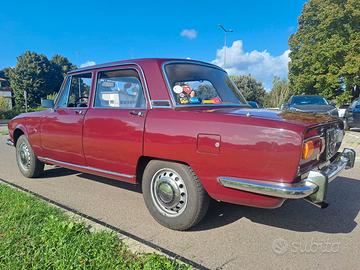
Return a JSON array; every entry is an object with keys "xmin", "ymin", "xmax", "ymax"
[{"xmin": 190, "ymin": 177, "xmax": 360, "ymax": 233}]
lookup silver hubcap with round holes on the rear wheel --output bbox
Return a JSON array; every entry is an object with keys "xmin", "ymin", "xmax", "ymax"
[{"xmin": 151, "ymin": 169, "xmax": 187, "ymax": 216}]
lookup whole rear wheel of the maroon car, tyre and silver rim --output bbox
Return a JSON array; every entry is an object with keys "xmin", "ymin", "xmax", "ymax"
[{"xmin": 142, "ymin": 160, "xmax": 209, "ymax": 231}]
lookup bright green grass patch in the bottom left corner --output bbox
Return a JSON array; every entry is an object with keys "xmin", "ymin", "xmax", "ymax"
[{"xmin": 0, "ymin": 184, "xmax": 189, "ymax": 270}]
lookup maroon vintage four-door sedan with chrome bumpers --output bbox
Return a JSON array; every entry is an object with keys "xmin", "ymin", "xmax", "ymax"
[{"xmin": 7, "ymin": 59, "xmax": 355, "ymax": 230}]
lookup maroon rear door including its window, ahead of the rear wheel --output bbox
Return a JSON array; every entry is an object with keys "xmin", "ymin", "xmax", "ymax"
[{"xmin": 83, "ymin": 66, "xmax": 147, "ymax": 181}]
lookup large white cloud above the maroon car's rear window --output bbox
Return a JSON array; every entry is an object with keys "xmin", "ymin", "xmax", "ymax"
[{"xmin": 212, "ymin": 40, "xmax": 290, "ymax": 89}]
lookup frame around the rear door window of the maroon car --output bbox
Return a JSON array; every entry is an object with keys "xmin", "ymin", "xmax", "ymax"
[{"xmin": 91, "ymin": 65, "xmax": 149, "ymax": 110}]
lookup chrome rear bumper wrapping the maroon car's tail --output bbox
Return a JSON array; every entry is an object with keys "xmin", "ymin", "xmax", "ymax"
[{"xmin": 218, "ymin": 148, "xmax": 356, "ymax": 204}]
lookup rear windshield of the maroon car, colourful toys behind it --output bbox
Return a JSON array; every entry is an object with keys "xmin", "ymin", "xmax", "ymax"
[{"xmin": 165, "ymin": 63, "xmax": 247, "ymax": 106}]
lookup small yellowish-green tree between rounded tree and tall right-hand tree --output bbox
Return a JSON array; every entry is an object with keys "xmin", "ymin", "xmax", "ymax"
[{"xmin": 264, "ymin": 77, "xmax": 291, "ymax": 108}]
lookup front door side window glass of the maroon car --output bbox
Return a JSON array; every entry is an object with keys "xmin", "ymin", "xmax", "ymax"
[{"xmin": 58, "ymin": 73, "xmax": 92, "ymax": 108}]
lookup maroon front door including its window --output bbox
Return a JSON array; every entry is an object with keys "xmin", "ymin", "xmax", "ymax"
[{"xmin": 41, "ymin": 73, "xmax": 92, "ymax": 165}]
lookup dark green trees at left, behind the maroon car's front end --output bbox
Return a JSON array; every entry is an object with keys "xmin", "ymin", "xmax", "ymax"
[{"xmin": 8, "ymin": 51, "xmax": 75, "ymax": 107}]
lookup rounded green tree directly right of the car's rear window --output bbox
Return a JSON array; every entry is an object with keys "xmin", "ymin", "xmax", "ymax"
[{"xmin": 230, "ymin": 75, "xmax": 266, "ymax": 104}]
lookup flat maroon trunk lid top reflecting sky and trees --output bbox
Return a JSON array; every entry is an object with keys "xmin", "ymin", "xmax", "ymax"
[{"xmin": 202, "ymin": 108, "xmax": 338, "ymax": 126}]
